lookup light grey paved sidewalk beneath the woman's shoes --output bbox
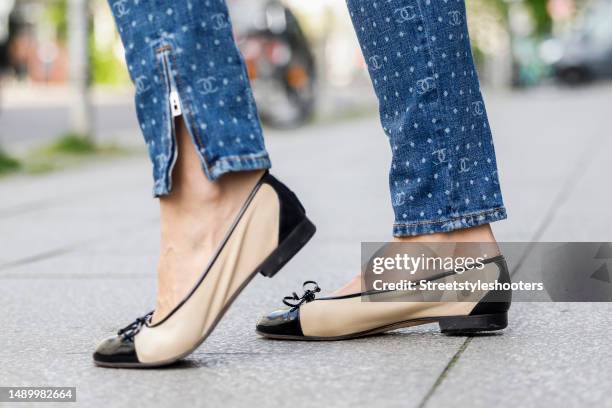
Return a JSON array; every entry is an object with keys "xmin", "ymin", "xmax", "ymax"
[{"xmin": 0, "ymin": 87, "xmax": 612, "ymax": 407}]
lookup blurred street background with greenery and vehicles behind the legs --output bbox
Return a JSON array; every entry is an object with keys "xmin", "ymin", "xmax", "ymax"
[{"xmin": 0, "ymin": 0, "xmax": 612, "ymax": 155}]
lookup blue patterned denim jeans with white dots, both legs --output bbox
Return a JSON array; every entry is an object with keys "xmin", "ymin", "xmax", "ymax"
[{"xmin": 109, "ymin": 0, "xmax": 506, "ymax": 236}]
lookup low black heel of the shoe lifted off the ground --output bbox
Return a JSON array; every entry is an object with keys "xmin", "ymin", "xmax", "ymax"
[{"xmin": 259, "ymin": 218, "xmax": 317, "ymax": 278}]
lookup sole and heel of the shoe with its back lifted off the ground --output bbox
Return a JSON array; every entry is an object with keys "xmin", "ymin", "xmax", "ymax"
[{"xmin": 94, "ymin": 217, "xmax": 317, "ymax": 368}]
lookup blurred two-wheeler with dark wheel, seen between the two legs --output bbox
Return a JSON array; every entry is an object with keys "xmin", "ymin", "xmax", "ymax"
[{"xmin": 228, "ymin": 0, "xmax": 317, "ymax": 128}]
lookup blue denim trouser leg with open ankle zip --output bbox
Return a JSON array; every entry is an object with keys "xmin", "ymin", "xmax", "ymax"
[{"xmin": 109, "ymin": 0, "xmax": 270, "ymax": 191}]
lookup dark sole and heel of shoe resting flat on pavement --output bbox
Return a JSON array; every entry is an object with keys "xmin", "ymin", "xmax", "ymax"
[{"xmin": 255, "ymin": 313, "xmax": 508, "ymax": 341}]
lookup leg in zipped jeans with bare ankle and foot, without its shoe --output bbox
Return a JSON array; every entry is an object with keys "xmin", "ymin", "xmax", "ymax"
[{"xmin": 109, "ymin": 0, "xmax": 270, "ymax": 320}]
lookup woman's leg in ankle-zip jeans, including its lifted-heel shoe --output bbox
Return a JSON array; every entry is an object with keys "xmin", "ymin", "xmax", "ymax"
[{"xmin": 93, "ymin": 0, "xmax": 315, "ymax": 367}]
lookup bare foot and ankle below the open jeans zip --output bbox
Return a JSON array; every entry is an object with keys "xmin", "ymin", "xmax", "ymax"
[{"xmin": 152, "ymin": 121, "xmax": 264, "ymax": 322}]
